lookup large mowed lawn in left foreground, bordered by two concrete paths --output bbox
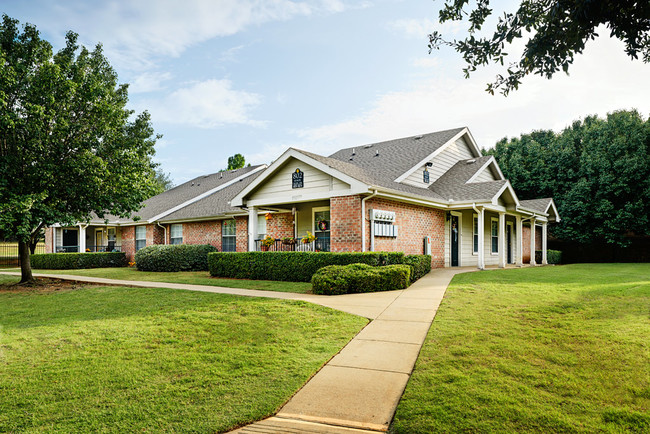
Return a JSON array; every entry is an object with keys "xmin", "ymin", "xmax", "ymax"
[{"xmin": 0, "ymin": 276, "xmax": 367, "ymax": 433}]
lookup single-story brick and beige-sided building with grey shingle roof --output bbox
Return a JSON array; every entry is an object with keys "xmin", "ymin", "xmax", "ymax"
[{"xmin": 46, "ymin": 128, "xmax": 560, "ymax": 268}]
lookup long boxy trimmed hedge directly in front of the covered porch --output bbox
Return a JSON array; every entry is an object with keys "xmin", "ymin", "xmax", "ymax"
[{"xmin": 208, "ymin": 252, "xmax": 404, "ymax": 282}]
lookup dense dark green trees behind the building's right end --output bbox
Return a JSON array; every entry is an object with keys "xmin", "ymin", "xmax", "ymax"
[{"xmin": 486, "ymin": 111, "xmax": 650, "ymax": 246}]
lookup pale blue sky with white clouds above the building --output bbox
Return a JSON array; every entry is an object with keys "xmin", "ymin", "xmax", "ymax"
[{"xmin": 5, "ymin": 0, "xmax": 650, "ymax": 184}]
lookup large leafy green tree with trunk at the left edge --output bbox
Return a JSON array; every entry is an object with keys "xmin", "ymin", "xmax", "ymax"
[{"xmin": 0, "ymin": 15, "xmax": 158, "ymax": 283}]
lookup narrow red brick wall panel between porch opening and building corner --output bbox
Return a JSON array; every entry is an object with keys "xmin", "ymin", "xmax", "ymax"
[{"xmin": 330, "ymin": 196, "xmax": 361, "ymax": 252}]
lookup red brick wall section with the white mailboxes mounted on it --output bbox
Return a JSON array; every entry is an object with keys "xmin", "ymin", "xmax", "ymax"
[{"xmin": 365, "ymin": 198, "xmax": 445, "ymax": 268}]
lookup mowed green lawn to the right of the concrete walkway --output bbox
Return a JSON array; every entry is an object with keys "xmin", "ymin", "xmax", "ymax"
[{"xmin": 391, "ymin": 264, "xmax": 650, "ymax": 433}]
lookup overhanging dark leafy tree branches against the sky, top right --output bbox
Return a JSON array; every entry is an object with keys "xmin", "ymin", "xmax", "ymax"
[{"xmin": 429, "ymin": 0, "xmax": 650, "ymax": 95}]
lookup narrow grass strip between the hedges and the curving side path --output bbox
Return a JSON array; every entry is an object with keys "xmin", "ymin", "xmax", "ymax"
[{"xmin": 14, "ymin": 267, "xmax": 311, "ymax": 294}]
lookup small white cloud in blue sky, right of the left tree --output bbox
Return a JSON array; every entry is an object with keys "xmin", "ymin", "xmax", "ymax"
[{"xmin": 142, "ymin": 79, "xmax": 266, "ymax": 128}]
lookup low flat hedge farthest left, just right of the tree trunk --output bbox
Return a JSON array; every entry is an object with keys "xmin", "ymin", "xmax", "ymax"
[{"xmin": 30, "ymin": 252, "xmax": 127, "ymax": 270}]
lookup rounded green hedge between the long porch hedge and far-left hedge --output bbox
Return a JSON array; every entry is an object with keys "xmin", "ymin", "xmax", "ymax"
[{"xmin": 135, "ymin": 244, "xmax": 217, "ymax": 271}]
